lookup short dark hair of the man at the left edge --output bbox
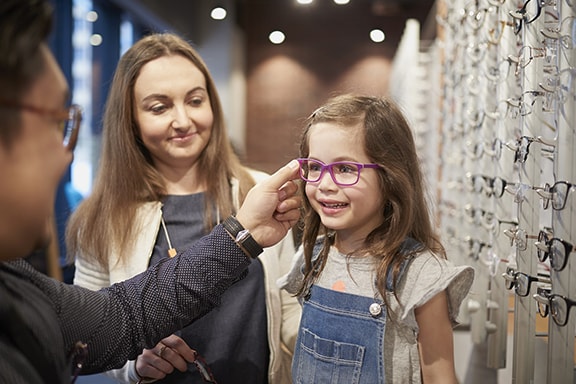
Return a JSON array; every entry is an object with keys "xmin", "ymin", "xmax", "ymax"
[{"xmin": 0, "ymin": 0, "xmax": 52, "ymax": 148}]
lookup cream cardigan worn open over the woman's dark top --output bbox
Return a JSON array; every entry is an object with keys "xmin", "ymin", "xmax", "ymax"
[{"xmin": 74, "ymin": 171, "xmax": 301, "ymax": 384}]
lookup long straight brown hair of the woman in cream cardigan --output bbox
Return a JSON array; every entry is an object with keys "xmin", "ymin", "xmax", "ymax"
[{"xmin": 66, "ymin": 33, "xmax": 254, "ymax": 266}]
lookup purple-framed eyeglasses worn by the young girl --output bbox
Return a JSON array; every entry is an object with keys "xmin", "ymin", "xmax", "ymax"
[{"xmin": 298, "ymin": 158, "xmax": 380, "ymax": 187}]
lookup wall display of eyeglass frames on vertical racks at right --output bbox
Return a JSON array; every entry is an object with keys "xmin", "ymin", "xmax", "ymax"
[{"xmin": 394, "ymin": 0, "xmax": 576, "ymax": 383}]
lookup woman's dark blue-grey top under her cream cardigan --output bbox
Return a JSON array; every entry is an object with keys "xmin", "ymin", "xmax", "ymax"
[{"xmin": 150, "ymin": 193, "xmax": 269, "ymax": 384}]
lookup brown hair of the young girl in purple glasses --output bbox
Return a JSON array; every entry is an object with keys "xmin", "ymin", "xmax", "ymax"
[{"xmin": 298, "ymin": 95, "xmax": 446, "ymax": 306}]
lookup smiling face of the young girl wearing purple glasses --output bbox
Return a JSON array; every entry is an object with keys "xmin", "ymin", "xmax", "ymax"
[{"xmin": 306, "ymin": 123, "xmax": 385, "ymax": 252}]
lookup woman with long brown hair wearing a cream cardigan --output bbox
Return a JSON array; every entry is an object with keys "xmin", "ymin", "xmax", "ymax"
[{"xmin": 67, "ymin": 34, "xmax": 300, "ymax": 383}]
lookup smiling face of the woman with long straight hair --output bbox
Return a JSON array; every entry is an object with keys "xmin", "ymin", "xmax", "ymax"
[{"xmin": 134, "ymin": 56, "xmax": 214, "ymax": 174}]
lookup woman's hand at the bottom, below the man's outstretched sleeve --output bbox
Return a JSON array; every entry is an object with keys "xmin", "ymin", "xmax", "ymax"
[{"xmin": 136, "ymin": 335, "xmax": 196, "ymax": 382}]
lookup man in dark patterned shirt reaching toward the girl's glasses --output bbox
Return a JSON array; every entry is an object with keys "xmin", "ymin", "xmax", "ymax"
[{"xmin": 0, "ymin": 0, "xmax": 300, "ymax": 384}]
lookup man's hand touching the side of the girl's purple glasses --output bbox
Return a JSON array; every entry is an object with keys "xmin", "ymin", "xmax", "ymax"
[{"xmin": 236, "ymin": 160, "xmax": 302, "ymax": 247}]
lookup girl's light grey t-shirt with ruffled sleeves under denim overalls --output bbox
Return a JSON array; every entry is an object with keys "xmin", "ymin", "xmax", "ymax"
[{"xmin": 278, "ymin": 247, "xmax": 474, "ymax": 383}]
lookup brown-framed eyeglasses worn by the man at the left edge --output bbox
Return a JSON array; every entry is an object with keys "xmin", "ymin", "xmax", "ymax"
[{"xmin": 0, "ymin": 99, "xmax": 82, "ymax": 151}]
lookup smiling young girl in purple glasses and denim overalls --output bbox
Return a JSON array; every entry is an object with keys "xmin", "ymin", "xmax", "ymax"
[{"xmin": 280, "ymin": 95, "xmax": 474, "ymax": 384}]
